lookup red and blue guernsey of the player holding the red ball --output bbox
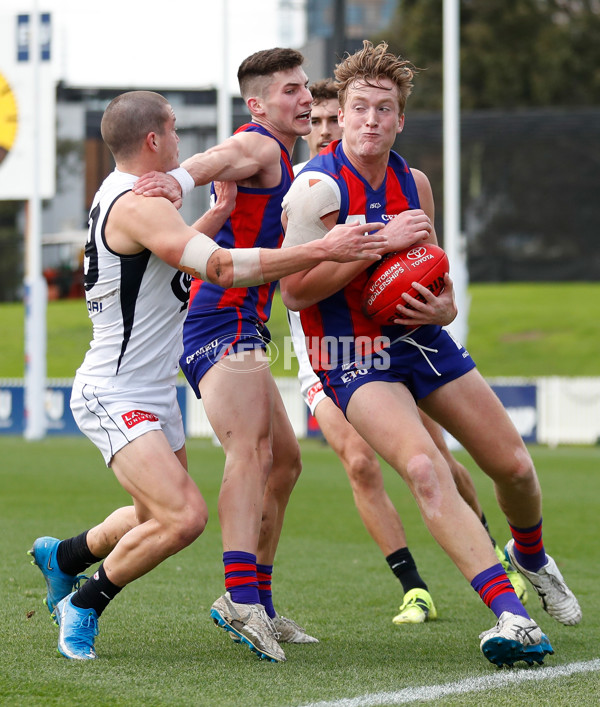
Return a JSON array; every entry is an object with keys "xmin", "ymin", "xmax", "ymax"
[{"xmin": 300, "ymin": 141, "xmax": 420, "ymax": 371}]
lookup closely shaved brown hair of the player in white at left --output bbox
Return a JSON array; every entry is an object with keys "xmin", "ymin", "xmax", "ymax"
[{"xmin": 100, "ymin": 91, "xmax": 169, "ymax": 159}]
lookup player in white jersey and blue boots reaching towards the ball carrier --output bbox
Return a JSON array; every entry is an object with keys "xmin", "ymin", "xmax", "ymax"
[{"xmin": 30, "ymin": 91, "xmax": 386, "ymax": 660}]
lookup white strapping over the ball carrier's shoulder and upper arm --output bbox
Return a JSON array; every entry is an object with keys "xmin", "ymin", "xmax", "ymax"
[{"xmin": 282, "ymin": 172, "xmax": 341, "ymax": 248}]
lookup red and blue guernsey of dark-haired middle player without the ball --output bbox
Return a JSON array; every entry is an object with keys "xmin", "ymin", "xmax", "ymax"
[{"xmin": 189, "ymin": 123, "xmax": 294, "ymax": 322}]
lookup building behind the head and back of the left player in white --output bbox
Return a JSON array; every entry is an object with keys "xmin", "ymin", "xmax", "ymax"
[{"xmin": 42, "ymin": 84, "xmax": 248, "ymax": 299}]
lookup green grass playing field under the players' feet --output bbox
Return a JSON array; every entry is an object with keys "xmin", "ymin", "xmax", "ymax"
[{"xmin": 0, "ymin": 437, "xmax": 600, "ymax": 707}]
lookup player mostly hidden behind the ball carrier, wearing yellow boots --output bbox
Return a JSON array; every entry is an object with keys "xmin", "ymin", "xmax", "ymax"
[{"xmin": 288, "ymin": 79, "xmax": 527, "ymax": 624}]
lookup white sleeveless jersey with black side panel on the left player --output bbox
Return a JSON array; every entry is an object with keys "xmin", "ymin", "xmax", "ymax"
[{"xmin": 77, "ymin": 170, "xmax": 191, "ymax": 389}]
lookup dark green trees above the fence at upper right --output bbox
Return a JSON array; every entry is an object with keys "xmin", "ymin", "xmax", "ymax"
[{"xmin": 375, "ymin": 0, "xmax": 600, "ymax": 110}]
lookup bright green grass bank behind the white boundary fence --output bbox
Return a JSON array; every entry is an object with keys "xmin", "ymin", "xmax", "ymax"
[{"xmin": 0, "ymin": 283, "xmax": 600, "ymax": 378}]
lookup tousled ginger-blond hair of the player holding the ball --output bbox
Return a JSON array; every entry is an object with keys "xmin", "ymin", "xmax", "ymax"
[{"xmin": 335, "ymin": 39, "xmax": 417, "ymax": 115}]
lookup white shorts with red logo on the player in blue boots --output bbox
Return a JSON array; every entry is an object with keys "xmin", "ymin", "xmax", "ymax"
[{"xmin": 71, "ymin": 378, "xmax": 185, "ymax": 466}]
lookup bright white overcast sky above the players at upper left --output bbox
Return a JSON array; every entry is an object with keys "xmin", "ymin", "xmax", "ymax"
[{"xmin": 0, "ymin": 0, "xmax": 303, "ymax": 92}]
